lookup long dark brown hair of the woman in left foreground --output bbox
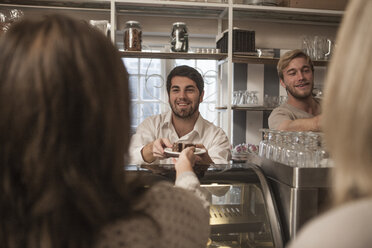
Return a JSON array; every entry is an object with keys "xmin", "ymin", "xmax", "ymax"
[{"xmin": 0, "ymin": 15, "xmax": 140, "ymax": 248}]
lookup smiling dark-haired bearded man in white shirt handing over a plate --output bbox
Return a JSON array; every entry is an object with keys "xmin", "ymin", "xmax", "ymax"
[{"xmin": 130, "ymin": 65, "xmax": 231, "ymax": 164}]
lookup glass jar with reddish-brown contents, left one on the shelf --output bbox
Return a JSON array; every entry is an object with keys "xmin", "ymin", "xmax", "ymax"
[{"xmin": 124, "ymin": 21, "xmax": 142, "ymax": 51}]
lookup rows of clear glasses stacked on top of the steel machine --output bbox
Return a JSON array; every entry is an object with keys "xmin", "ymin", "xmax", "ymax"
[{"xmin": 259, "ymin": 129, "xmax": 331, "ymax": 167}]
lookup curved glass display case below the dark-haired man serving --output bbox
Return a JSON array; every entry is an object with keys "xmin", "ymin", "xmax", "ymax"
[{"xmin": 127, "ymin": 163, "xmax": 283, "ymax": 248}]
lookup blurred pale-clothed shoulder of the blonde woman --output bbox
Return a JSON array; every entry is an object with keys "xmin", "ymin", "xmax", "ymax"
[{"xmin": 289, "ymin": 198, "xmax": 372, "ymax": 248}]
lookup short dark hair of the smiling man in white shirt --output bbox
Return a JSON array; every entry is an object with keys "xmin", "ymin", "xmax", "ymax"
[{"xmin": 167, "ymin": 65, "xmax": 204, "ymax": 96}]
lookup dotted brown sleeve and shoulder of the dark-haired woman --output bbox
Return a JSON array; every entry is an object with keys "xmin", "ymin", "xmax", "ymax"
[{"xmin": 97, "ymin": 182, "xmax": 209, "ymax": 248}]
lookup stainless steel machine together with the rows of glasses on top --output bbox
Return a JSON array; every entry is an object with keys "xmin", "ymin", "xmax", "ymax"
[{"xmin": 252, "ymin": 129, "xmax": 333, "ymax": 242}]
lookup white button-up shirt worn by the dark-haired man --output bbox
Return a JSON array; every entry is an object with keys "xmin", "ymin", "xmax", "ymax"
[{"xmin": 129, "ymin": 111, "xmax": 231, "ymax": 164}]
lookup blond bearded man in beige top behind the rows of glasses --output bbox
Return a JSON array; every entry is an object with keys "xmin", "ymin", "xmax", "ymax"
[{"xmin": 269, "ymin": 50, "xmax": 321, "ymax": 131}]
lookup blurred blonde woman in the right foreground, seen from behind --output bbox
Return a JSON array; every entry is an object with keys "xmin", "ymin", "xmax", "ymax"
[{"xmin": 290, "ymin": 0, "xmax": 372, "ymax": 248}]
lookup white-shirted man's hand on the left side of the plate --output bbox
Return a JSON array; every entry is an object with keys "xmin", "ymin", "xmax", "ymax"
[{"xmin": 141, "ymin": 138, "xmax": 172, "ymax": 163}]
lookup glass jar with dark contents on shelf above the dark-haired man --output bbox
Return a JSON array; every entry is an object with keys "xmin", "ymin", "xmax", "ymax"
[{"xmin": 171, "ymin": 22, "xmax": 189, "ymax": 52}]
